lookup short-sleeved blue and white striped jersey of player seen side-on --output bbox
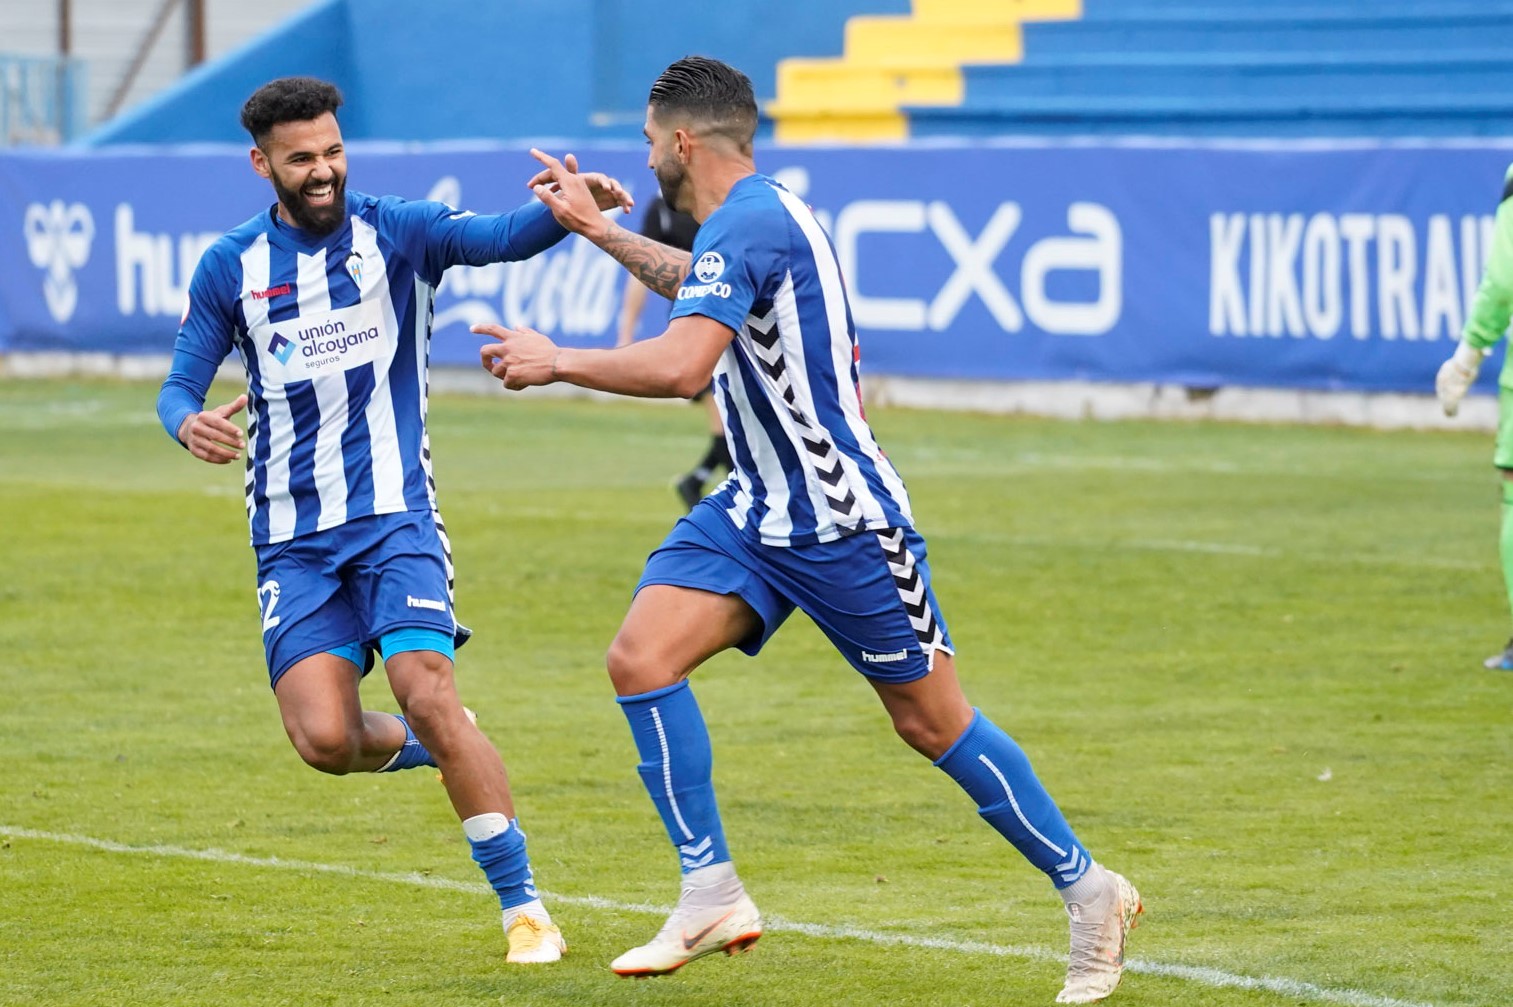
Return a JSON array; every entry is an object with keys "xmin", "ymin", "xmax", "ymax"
[{"xmin": 672, "ymin": 175, "xmax": 914, "ymax": 546}]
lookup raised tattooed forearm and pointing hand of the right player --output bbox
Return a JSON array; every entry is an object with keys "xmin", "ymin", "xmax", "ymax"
[{"xmin": 527, "ymin": 148, "xmax": 693, "ymax": 301}]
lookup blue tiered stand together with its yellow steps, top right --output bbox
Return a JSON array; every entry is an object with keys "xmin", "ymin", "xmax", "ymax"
[{"xmin": 769, "ymin": 0, "xmax": 1513, "ymax": 142}]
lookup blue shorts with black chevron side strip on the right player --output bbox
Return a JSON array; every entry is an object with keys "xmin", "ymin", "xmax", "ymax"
[{"xmin": 635, "ymin": 497, "xmax": 955, "ymax": 682}]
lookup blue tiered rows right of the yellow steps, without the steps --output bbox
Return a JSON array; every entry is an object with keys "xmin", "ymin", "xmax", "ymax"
[{"xmin": 905, "ymin": 0, "xmax": 1513, "ymax": 136}]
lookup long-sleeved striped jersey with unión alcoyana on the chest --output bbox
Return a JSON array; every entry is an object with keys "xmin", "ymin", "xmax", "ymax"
[{"xmin": 159, "ymin": 191, "xmax": 566, "ymax": 546}]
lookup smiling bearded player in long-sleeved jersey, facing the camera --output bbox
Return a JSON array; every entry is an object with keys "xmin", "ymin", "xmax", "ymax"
[{"xmin": 157, "ymin": 77, "xmax": 631, "ymax": 963}]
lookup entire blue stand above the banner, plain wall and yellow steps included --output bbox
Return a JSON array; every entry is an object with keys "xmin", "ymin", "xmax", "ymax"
[{"xmin": 47, "ymin": 0, "xmax": 1513, "ymax": 145}]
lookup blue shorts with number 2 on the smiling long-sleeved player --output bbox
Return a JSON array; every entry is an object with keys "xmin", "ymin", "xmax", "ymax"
[{"xmin": 254, "ymin": 511, "xmax": 472, "ymax": 688}]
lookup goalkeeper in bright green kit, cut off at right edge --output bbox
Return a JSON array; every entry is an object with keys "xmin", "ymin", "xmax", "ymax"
[{"xmin": 1434, "ymin": 165, "xmax": 1513, "ymax": 671}]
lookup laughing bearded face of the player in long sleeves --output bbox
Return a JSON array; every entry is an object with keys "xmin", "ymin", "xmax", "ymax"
[{"xmin": 251, "ymin": 112, "xmax": 346, "ymax": 236}]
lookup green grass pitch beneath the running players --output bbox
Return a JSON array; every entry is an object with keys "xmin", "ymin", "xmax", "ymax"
[{"xmin": 0, "ymin": 381, "xmax": 1513, "ymax": 1007}]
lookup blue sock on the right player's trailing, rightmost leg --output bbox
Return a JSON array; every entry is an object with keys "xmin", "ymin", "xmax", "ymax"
[{"xmin": 935, "ymin": 709, "xmax": 1092, "ymax": 888}]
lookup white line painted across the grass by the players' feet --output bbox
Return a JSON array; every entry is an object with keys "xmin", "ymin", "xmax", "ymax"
[{"xmin": 0, "ymin": 826, "xmax": 1434, "ymax": 1007}]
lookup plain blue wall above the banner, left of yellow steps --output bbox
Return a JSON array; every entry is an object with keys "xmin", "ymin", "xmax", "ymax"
[{"xmin": 85, "ymin": 0, "xmax": 909, "ymax": 145}]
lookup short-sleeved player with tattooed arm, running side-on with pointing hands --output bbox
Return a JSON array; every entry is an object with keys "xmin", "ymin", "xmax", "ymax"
[{"xmin": 474, "ymin": 56, "xmax": 1142, "ymax": 1004}]
